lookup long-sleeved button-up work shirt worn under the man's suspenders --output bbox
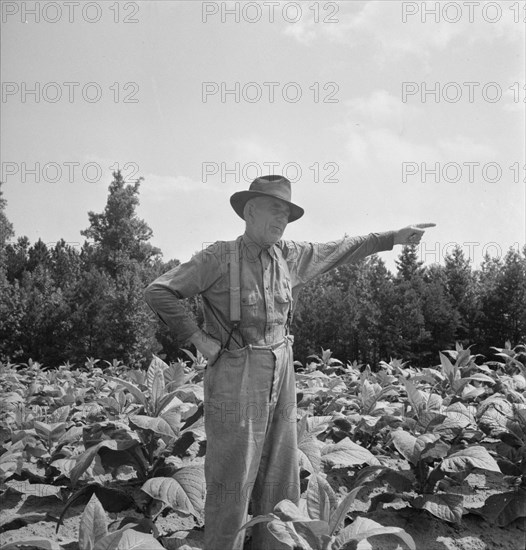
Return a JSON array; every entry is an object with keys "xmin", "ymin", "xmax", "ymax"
[{"xmin": 145, "ymin": 231, "xmax": 394, "ymax": 349}]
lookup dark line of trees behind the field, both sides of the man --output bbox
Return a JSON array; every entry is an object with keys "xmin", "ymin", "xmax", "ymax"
[{"xmin": 0, "ymin": 172, "xmax": 526, "ymax": 367}]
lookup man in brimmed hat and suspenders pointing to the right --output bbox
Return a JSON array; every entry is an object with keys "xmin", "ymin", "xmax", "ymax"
[{"xmin": 145, "ymin": 175, "xmax": 434, "ymax": 550}]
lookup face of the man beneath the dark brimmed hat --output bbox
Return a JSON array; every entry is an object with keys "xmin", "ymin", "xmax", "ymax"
[{"xmin": 246, "ymin": 197, "xmax": 290, "ymax": 246}]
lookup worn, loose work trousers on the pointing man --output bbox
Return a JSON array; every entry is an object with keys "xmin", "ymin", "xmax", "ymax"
[{"xmin": 204, "ymin": 337, "xmax": 300, "ymax": 550}]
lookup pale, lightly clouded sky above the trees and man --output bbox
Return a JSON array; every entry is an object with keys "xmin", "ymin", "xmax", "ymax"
[{"xmin": 0, "ymin": 0, "xmax": 526, "ymax": 274}]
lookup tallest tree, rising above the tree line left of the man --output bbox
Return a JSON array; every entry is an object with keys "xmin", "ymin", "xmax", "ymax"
[{"xmin": 76, "ymin": 172, "xmax": 161, "ymax": 364}]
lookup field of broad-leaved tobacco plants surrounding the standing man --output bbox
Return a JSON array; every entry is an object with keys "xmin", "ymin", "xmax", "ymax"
[{"xmin": 0, "ymin": 342, "xmax": 526, "ymax": 550}]
